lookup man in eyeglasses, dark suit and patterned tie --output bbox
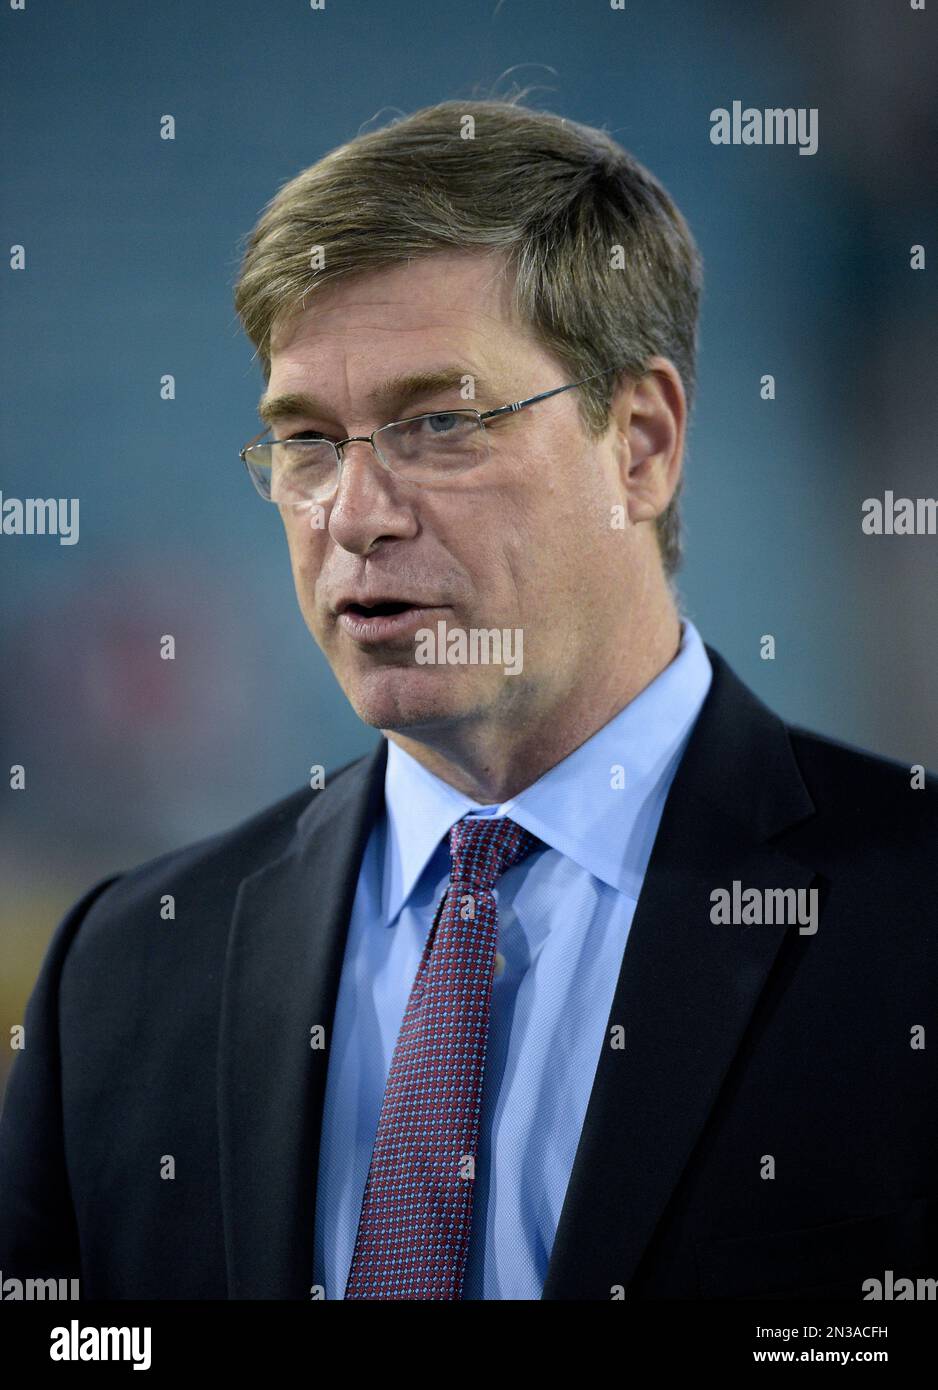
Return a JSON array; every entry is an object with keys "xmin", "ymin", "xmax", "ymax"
[{"xmin": 0, "ymin": 103, "xmax": 938, "ymax": 1300}]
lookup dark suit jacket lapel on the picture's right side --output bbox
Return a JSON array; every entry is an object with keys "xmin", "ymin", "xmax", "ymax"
[{"xmin": 542, "ymin": 648, "xmax": 814, "ymax": 1300}]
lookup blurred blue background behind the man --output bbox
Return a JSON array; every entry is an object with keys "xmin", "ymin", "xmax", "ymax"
[{"xmin": 0, "ymin": 0, "xmax": 938, "ymax": 1084}]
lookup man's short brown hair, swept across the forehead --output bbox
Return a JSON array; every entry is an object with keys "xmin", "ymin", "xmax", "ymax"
[{"xmin": 235, "ymin": 95, "xmax": 702, "ymax": 575}]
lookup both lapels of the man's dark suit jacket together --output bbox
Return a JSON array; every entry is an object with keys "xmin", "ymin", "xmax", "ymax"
[{"xmin": 218, "ymin": 646, "xmax": 814, "ymax": 1298}]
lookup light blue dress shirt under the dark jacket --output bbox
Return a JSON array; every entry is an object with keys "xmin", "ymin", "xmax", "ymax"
[{"xmin": 313, "ymin": 619, "xmax": 713, "ymax": 1300}]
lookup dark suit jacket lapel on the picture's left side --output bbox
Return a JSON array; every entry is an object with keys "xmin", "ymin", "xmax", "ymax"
[{"xmin": 218, "ymin": 738, "xmax": 388, "ymax": 1298}]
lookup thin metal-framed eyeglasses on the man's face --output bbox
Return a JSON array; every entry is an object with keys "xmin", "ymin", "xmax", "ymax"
[{"xmin": 239, "ymin": 367, "xmax": 620, "ymax": 506}]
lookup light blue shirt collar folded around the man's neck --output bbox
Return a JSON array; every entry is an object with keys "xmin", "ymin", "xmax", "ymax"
[{"xmin": 382, "ymin": 619, "xmax": 713, "ymax": 926}]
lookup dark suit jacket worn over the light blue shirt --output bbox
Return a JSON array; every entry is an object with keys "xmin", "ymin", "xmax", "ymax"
[{"xmin": 0, "ymin": 648, "xmax": 938, "ymax": 1300}]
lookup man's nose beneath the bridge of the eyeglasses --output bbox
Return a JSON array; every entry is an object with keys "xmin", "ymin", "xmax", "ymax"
[{"xmin": 329, "ymin": 438, "xmax": 417, "ymax": 555}]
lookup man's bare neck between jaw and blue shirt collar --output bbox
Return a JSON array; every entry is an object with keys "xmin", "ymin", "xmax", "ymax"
[{"xmin": 382, "ymin": 595, "xmax": 681, "ymax": 805}]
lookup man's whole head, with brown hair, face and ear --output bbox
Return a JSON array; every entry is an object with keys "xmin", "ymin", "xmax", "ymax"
[{"xmin": 236, "ymin": 103, "xmax": 700, "ymax": 772}]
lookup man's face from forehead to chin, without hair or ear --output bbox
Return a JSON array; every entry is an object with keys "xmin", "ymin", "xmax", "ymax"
[{"xmin": 267, "ymin": 253, "xmax": 644, "ymax": 738}]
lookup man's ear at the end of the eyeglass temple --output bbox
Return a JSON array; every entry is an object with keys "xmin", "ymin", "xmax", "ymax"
[{"xmin": 613, "ymin": 357, "xmax": 686, "ymax": 523}]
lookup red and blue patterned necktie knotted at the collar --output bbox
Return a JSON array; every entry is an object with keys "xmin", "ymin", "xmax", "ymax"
[{"xmin": 345, "ymin": 817, "xmax": 541, "ymax": 1300}]
